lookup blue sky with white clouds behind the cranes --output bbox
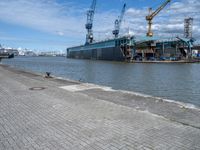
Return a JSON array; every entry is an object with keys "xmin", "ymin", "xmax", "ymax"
[{"xmin": 0, "ymin": 0, "xmax": 200, "ymax": 50}]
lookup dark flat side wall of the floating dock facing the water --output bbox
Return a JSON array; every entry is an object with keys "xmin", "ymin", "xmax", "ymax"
[{"xmin": 67, "ymin": 47, "xmax": 125, "ymax": 61}]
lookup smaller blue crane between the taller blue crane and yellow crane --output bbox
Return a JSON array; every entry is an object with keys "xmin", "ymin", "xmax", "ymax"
[{"xmin": 112, "ymin": 4, "xmax": 126, "ymax": 38}]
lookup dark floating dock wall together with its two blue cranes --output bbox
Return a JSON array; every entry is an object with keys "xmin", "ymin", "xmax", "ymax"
[{"xmin": 67, "ymin": 0, "xmax": 135, "ymax": 61}]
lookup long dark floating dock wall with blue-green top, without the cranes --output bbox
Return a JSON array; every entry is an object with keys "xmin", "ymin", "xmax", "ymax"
[{"xmin": 67, "ymin": 36, "xmax": 135, "ymax": 61}]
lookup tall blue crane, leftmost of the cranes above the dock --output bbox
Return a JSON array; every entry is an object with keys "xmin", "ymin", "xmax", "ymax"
[{"xmin": 85, "ymin": 0, "xmax": 96, "ymax": 44}]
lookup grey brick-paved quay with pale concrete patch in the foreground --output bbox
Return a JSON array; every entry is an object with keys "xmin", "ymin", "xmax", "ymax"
[{"xmin": 0, "ymin": 65, "xmax": 200, "ymax": 150}]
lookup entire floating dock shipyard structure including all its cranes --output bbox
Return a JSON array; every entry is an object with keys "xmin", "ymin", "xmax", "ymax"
[{"xmin": 67, "ymin": 0, "xmax": 200, "ymax": 62}]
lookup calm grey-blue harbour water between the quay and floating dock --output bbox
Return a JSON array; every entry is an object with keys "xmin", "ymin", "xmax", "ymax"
[{"xmin": 2, "ymin": 57, "xmax": 200, "ymax": 106}]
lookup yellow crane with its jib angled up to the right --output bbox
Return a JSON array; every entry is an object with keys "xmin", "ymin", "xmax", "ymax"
[{"xmin": 146, "ymin": 0, "xmax": 171, "ymax": 37}]
